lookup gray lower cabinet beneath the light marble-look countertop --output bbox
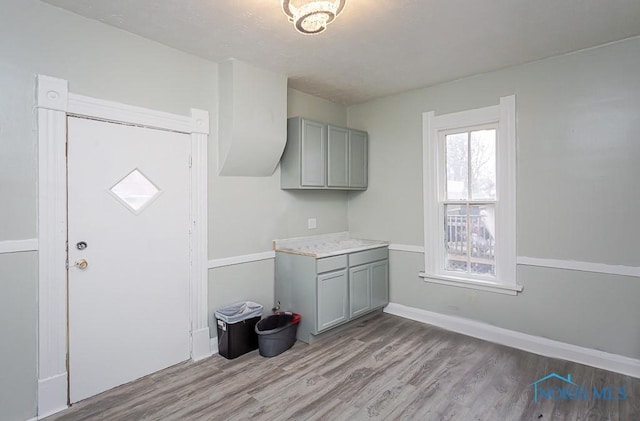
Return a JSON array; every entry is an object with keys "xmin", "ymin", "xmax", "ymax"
[{"xmin": 275, "ymin": 246, "xmax": 389, "ymax": 342}]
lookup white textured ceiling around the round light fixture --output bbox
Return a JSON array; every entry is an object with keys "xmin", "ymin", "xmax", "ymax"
[{"xmin": 43, "ymin": 0, "xmax": 640, "ymax": 104}]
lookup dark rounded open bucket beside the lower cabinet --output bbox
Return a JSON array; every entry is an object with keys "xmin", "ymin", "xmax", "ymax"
[{"xmin": 255, "ymin": 312, "xmax": 300, "ymax": 357}]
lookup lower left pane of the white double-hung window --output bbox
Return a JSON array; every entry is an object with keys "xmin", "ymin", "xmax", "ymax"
[{"xmin": 444, "ymin": 204, "xmax": 468, "ymax": 272}]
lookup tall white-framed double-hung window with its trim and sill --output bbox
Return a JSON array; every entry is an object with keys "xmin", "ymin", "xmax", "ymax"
[{"xmin": 420, "ymin": 96, "xmax": 522, "ymax": 295}]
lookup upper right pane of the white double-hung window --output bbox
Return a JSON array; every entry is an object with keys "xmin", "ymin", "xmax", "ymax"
[{"xmin": 470, "ymin": 129, "xmax": 496, "ymax": 200}]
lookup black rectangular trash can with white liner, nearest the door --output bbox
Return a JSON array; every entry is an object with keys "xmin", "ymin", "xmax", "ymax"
[{"xmin": 215, "ymin": 301, "xmax": 262, "ymax": 360}]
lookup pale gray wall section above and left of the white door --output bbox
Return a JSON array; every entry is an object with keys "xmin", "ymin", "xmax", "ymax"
[{"xmin": 0, "ymin": 0, "xmax": 217, "ymax": 420}]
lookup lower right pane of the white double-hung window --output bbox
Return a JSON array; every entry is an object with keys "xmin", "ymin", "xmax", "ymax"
[{"xmin": 469, "ymin": 205, "xmax": 496, "ymax": 275}]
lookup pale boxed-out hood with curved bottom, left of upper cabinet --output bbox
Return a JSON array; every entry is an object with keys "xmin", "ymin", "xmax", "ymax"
[{"xmin": 218, "ymin": 59, "xmax": 287, "ymax": 177}]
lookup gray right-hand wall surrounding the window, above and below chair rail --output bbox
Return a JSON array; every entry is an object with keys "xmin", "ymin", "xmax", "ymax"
[{"xmin": 348, "ymin": 38, "xmax": 640, "ymax": 358}]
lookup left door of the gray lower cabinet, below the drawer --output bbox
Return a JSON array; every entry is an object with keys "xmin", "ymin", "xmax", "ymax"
[{"xmin": 317, "ymin": 269, "xmax": 349, "ymax": 332}]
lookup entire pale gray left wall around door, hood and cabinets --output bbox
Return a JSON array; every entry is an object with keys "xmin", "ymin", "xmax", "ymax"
[{"xmin": 0, "ymin": 0, "xmax": 347, "ymax": 420}]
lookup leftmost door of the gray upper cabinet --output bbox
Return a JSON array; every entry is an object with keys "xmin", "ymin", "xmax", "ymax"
[{"xmin": 300, "ymin": 120, "xmax": 326, "ymax": 187}]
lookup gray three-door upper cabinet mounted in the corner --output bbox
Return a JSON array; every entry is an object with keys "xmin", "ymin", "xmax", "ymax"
[{"xmin": 280, "ymin": 117, "xmax": 368, "ymax": 190}]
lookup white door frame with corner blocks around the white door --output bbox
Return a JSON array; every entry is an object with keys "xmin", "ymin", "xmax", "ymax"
[{"xmin": 36, "ymin": 75, "xmax": 211, "ymax": 418}]
